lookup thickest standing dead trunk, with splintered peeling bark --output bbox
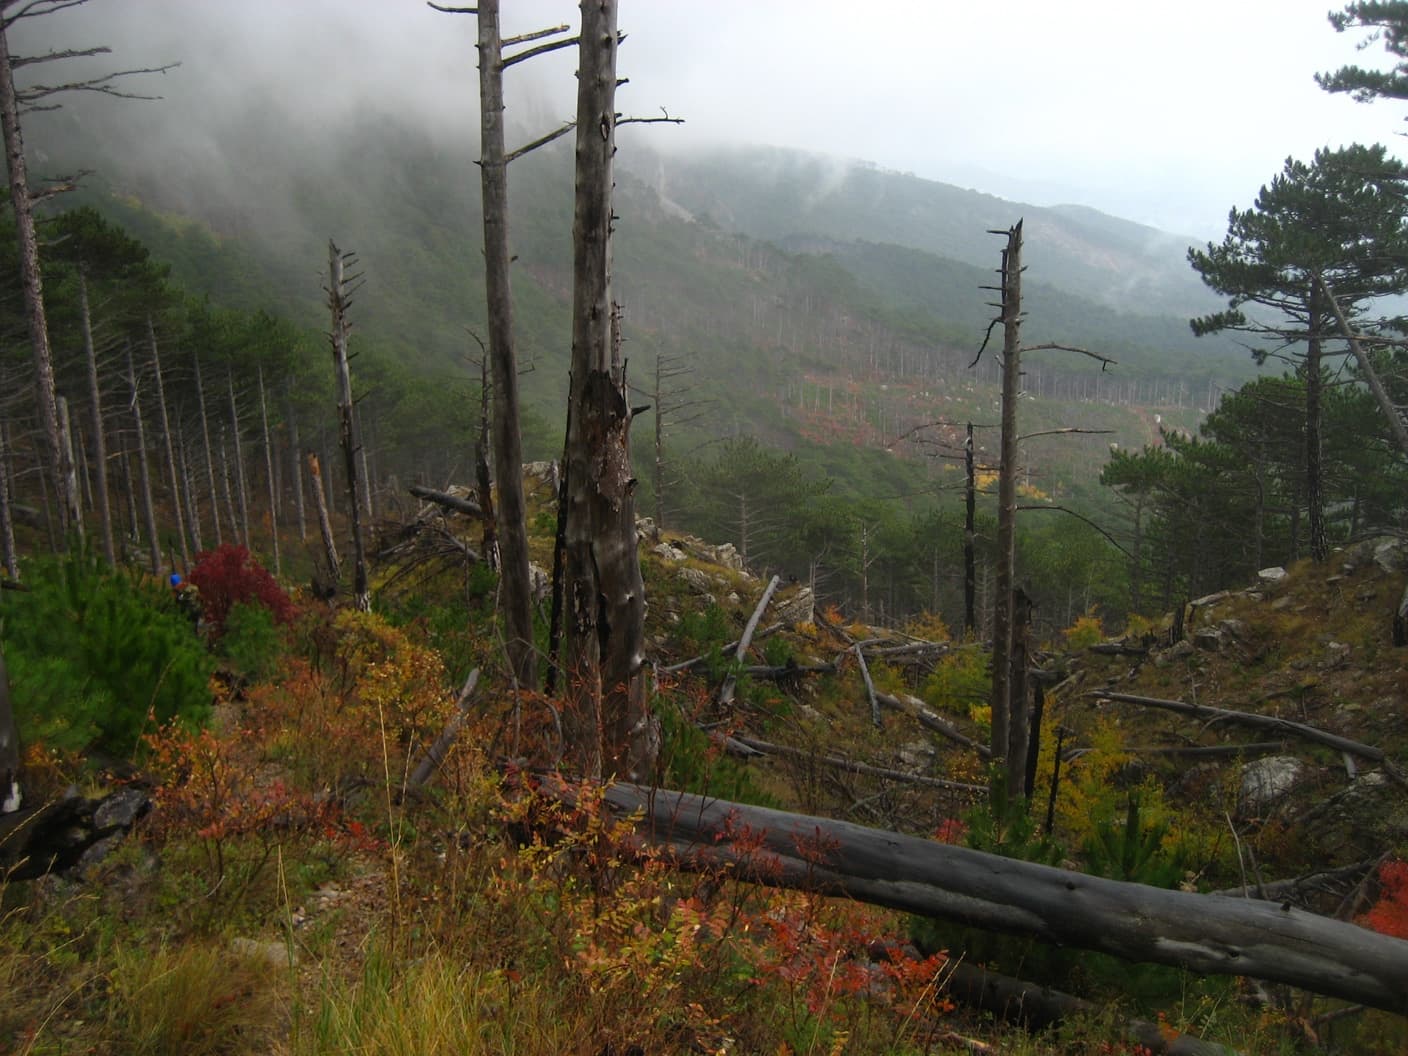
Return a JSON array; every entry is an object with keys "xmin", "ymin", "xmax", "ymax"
[{"xmin": 565, "ymin": 0, "xmax": 659, "ymax": 779}]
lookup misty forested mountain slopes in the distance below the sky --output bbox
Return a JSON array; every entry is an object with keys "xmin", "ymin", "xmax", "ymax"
[{"xmin": 28, "ymin": 99, "xmax": 1250, "ymax": 506}]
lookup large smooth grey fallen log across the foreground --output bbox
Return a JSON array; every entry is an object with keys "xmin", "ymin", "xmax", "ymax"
[{"xmin": 571, "ymin": 777, "xmax": 1408, "ymax": 1014}]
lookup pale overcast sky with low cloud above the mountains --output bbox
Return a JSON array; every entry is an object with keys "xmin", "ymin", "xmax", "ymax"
[{"xmin": 17, "ymin": 0, "xmax": 1408, "ymax": 238}]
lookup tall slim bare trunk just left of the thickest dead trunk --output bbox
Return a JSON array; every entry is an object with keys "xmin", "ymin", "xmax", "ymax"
[{"xmin": 479, "ymin": 0, "xmax": 532, "ymax": 690}]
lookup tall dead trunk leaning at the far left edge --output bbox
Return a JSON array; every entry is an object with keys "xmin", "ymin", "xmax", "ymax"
[{"xmin": 0, "ymin": 20, "xmax": 77, "ymax": 548}]
